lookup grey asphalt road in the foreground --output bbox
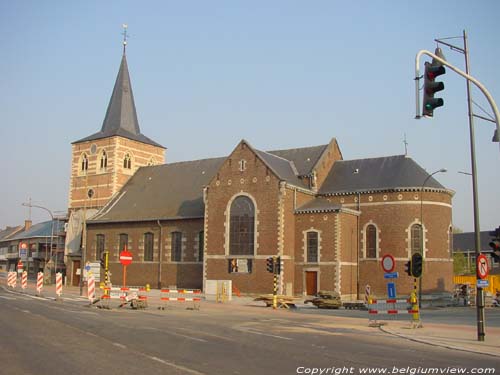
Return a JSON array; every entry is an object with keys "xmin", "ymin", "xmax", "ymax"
[{"xmin": 0, "ymin": 288, "xmax": 500, "ymax": 375}]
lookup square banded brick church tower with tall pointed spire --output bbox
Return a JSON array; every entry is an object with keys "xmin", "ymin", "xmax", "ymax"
[{"xmin": 68, "ymin": 33, "xmax": 165, "ymax": 212}]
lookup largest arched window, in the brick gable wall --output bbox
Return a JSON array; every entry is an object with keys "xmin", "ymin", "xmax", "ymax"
[{"xmin": 229, "ymin": 196, "xmax": 255, "ymax": 255}]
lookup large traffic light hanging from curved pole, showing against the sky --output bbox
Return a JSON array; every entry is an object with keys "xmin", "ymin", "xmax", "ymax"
[{"xmin": 422, "ymin": 48, "xmax": 446, "ymax": 117}]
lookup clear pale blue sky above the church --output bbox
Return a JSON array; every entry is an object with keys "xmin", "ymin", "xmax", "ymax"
[{"xmin": 0, "ymin": 0, "xmax": 500, "ymax": 231}]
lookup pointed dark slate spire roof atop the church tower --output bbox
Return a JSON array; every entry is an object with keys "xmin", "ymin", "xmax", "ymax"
[{"xmin": 73, "ymin": 54, "xmax": 165, "ymax": 148}]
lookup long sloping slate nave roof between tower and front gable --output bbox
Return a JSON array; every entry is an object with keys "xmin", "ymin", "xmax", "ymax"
[{"xmin": 89, "ymin": 158, "xmax": 226, "ymax": 223}]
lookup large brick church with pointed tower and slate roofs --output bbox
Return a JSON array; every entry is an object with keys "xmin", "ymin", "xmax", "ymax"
[{"xmin": 67, "ymin": 43, "xmax": 454, "ymax": 299}]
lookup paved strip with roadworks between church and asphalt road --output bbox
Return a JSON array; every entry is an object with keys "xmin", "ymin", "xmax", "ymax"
[{"xmin": 0, "ymin": 279, "xmax": 500, "ymax": 357}]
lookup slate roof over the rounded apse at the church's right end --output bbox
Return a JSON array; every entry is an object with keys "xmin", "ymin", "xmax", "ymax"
[{"xmin": 319, "ymin": 155, "xmax": 452, "ymax": 195}]
